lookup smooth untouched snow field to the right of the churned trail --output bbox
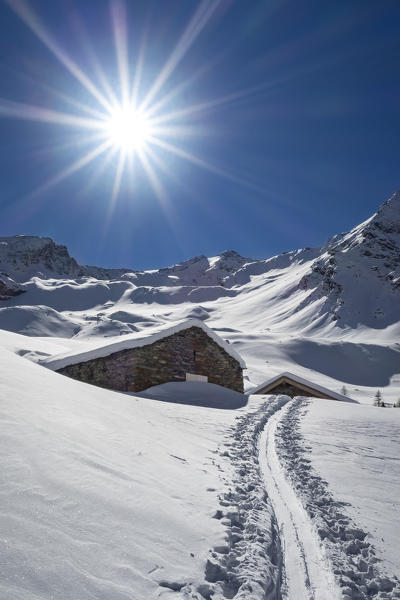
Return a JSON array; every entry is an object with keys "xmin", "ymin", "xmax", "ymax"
[{"xmin": 299, "ymin": 399, "xmax": 400, "ymax": 576}]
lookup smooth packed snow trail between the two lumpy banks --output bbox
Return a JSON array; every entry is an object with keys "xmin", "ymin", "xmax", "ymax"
[{"xmin": 259, "ymin": 402, "xmax": 341, "ymax": 600}]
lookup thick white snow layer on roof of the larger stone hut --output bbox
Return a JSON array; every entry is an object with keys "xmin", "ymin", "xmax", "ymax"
[{"xmin": 42, "ymin": 319, "xmax": 246, "ymax": 371}]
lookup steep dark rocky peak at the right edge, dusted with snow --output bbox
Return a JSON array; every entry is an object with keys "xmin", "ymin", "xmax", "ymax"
[{"xmin": 298, "ymin": 192, "xmax": 400, "ymax": 327}]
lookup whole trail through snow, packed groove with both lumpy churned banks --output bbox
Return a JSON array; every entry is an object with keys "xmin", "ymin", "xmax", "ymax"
[{"xmin": 175, "ymin": 396, "xmax": 400, "ymax": 600}]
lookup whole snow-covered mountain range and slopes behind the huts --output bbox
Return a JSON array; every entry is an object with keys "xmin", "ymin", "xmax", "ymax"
[{"xmin": 0, "ymin": 192, "xmax": 400, "ymax": 400}]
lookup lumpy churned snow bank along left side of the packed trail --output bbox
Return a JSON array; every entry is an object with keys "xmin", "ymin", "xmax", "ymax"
[{"xmin": 172, "ymin": 396, "xmax": 288, "ymax": 600}]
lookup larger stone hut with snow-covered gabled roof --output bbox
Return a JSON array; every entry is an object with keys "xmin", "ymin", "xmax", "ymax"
[{"xmin": 43, "ymin": 319, "xmax": 245, "ymax": 393}]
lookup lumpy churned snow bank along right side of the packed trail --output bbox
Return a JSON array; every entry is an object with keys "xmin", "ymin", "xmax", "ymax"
[{"xmin": 276, "ymin": 397, "xmax": 400, "ymax": 600}]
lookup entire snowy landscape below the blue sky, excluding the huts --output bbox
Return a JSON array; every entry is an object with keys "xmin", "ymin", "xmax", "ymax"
[{"xmin": 0, "ymin": 192, "xmax": 400, "ymax": 600}]
